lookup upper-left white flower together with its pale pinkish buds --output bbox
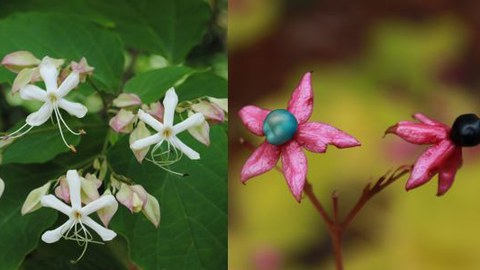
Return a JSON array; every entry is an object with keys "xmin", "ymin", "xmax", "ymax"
[{"xmin": 0, "ymin": 51, "xmax": 93, "ymax": 152}]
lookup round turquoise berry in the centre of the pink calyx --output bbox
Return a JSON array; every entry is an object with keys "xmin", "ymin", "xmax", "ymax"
[{"xmin": 263, "ymin": 109, "xmax": 298, "ymax": 145}]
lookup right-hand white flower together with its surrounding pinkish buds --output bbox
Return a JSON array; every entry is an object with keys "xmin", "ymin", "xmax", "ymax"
[{"xmin": 110, "ymin": 88, "xmax": 228, "ymax": 175}]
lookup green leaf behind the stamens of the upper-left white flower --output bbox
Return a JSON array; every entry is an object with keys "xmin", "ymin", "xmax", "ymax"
[{"xmin": 2, "ymin": 116, "xmax": 106, "ymax": 164}]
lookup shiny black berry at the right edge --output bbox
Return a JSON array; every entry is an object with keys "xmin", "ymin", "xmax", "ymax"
[{"xmin": 450, "ymin": 113, "xmax": 480, "ymax": 147}]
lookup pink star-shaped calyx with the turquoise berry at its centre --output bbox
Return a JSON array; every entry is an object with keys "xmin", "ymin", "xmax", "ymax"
[{"xmin": 239, "ymin": 72, "xmax": 360, "ymax": 202}]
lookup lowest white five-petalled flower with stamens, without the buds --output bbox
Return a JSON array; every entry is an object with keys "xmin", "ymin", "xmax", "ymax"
[{"xmin": 41, "ymin": 170, "xmax": 118, "ymax": 258}]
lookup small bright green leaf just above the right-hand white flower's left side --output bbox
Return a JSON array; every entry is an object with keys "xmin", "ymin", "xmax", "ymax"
[{"xmin": 125, "ymin": 67, "xmax": 194, "ymax": 103}]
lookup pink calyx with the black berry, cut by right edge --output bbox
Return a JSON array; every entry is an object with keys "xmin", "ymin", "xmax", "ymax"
[{"xmin": 385, "ymin": 113, "xmax": 480, "ymax": 196}]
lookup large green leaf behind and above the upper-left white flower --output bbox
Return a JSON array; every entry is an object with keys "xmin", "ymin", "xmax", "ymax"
[{"xmin": 0, "ymin": 13, "xmax": 124, "ymax": 93}]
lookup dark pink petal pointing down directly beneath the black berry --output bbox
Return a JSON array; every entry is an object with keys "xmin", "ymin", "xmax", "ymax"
[{"xmin": 437, "ymin": 147, "xmax": 462, "ymax": 196}]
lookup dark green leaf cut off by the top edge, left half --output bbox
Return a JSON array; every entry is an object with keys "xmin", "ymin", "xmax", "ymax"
[{"xmin": 89, "ymin": 0, "xmax": 210, "ymax": 64}]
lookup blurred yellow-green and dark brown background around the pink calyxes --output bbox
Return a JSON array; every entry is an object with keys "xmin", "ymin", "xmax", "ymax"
[{"xmin": 228, "ymin": 0, "xmax": 480, "ymax": 270}]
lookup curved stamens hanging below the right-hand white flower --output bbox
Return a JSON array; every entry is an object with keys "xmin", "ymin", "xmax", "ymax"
[{"xmin": 146, "ymin": 140, "xmax": 185, "ymax": 176}]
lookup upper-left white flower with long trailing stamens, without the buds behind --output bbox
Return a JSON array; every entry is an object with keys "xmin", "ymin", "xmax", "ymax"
[{"xmin": 2, "ymin": 56, "xmax": 87, "ymax": 151}]
